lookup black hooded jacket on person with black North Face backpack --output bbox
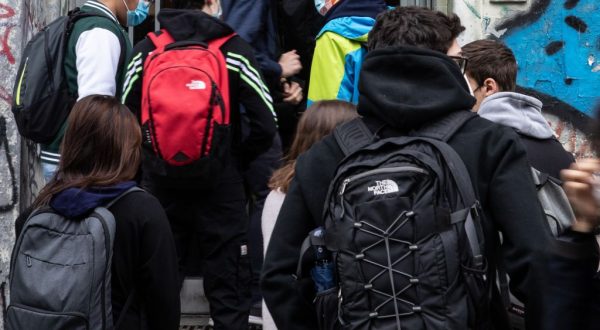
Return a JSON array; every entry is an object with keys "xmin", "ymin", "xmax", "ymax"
[{"xmin": 262, "ymin": 47, "xmax": 550, "ymax": 330}]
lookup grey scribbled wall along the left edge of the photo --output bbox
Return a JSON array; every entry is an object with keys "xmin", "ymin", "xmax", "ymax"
[{"xmin": 0, "ymin": 0, "xmax": 72, "ymax": 329}]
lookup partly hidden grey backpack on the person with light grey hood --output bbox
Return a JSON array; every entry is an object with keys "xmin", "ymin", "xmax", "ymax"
[{"xmin": 498, "ymin": 167, "xmax": 575, "ymax": 330}]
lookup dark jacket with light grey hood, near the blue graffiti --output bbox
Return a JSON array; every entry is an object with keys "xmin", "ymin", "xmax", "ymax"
[{"xmin": 478, "ymin": 92, "xmax": 575, "ymax": 179}]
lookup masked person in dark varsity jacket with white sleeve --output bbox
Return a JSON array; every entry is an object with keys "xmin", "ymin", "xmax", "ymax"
[{"xmin": 41, "ymin": 0, "xmax": 149, "ymax": 181}]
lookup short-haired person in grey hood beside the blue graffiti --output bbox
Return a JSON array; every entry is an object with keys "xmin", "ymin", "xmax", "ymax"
[{"xmin": 462, "ymin": 40, "xmax": 575, "ymax": 179}]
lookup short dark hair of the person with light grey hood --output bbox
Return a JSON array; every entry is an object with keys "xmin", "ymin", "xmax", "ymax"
[{"xmin": 462, "ymin": 40, "xmax": 517, "ymax": 91}]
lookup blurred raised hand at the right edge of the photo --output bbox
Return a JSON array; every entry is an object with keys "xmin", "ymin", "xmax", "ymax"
[{"xmin": 560, "ymin": 158, "xmax": 600, "ymax": 232}]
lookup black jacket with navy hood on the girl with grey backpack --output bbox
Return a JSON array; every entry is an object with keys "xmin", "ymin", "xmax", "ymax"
[{"xmin": 15, "ymin": 181, "xmax": 180, "ymax": 330}]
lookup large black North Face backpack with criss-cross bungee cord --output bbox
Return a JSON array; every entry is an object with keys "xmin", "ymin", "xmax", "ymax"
[{"xmin": 315, "ymin": 111, "xmax": 491, "ymax": 330}]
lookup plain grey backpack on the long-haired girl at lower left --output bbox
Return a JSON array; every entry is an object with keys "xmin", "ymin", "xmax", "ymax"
[{"xmin": 6, "ymin": 187, "xmax": 142, "ymax": 330}]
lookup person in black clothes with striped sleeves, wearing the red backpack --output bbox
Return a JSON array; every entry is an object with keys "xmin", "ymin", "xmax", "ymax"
[{"xmin": 123, "ymin": 0, "xmax": 277, "ymax": 329}]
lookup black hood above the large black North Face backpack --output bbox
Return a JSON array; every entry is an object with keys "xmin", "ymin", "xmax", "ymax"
[{"xmin": 358, "ymin": 47, "xmax": 475, "ymax": 130}]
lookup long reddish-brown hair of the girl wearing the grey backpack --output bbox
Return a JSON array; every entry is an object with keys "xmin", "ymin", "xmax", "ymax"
[{"xmin": 33, "ymin": 95, "xmax": 142, "ymax": 207}]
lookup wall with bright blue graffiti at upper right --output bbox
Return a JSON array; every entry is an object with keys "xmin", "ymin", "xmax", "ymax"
[{"xmin": 454, "ymin": 0, "xmax": 600, "ymax": 157}]
